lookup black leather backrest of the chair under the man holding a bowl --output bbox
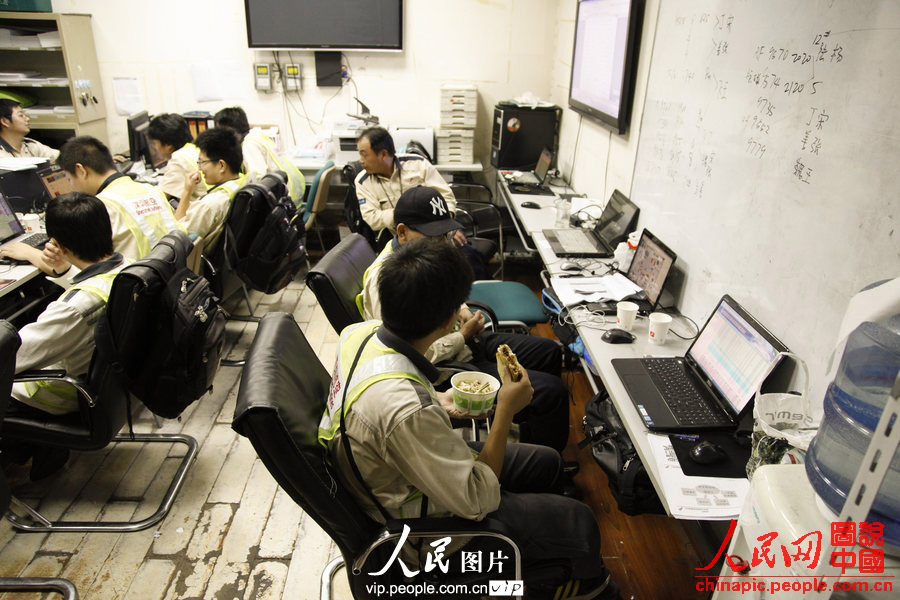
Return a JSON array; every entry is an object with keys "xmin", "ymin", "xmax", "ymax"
[{"xmin": 232, "ymin": 313, "xmax": 379, "ymax": 558}]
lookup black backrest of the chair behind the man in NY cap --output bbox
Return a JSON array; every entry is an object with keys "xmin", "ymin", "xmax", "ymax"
[{"xmin": 306, "ymin": 233, "xmax": 375, "ymax": 333}]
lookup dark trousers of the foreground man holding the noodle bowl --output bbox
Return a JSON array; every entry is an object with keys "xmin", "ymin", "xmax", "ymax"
[{"xmin": 469, "ymin": 442, "xmax": 606, "ymax": 586}]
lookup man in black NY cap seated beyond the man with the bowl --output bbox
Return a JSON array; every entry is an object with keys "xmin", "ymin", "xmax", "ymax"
[{"xmin": 357, "ymin": 186, "xmax": 569, "ymax": 451}]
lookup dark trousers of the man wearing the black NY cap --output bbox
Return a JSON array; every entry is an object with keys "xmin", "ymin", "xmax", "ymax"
[{"xmin": 472, "ymin": 333, "xmax": 569, "ymax": 451}]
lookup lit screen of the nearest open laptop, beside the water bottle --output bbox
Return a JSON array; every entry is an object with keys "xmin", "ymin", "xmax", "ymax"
[{"xmin": 687, "ymin": 296, "xmax": 786, "ymax": 415}]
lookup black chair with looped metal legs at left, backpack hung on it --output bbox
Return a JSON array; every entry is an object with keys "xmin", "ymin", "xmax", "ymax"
[{"xmin": 0, "ymin": 241, "xmax": 198, "ymax": 533}]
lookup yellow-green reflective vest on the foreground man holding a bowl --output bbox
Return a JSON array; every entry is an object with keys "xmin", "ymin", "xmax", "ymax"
[{"xmin": 318, "ymin": 321, "xmax": 437, "ymax": 448}]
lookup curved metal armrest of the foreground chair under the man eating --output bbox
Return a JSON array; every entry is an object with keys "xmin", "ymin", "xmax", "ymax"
[{"xmin": 352, "ymin": 517, "xmax": 522, "ymax": 579}]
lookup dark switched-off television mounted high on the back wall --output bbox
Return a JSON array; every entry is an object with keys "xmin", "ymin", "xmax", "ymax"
[{"xmin": 244, "ymin": 0, "xmax": 403, "ymax": 51}]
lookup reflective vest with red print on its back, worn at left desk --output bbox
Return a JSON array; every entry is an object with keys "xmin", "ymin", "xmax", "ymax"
[{"xmin": 97, "ymin": 177, "xmax": 186, "ymax": 258}]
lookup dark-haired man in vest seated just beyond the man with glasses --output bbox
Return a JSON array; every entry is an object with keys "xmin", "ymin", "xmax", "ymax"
[{"xmin": 147, "ymin": 113, "xmax": 207, "ymax": 206}]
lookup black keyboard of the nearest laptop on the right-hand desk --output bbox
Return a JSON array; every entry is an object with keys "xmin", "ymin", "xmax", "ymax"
[{"xmin": 641, "ymin": 358, "xmax": 731, "ymax": 426}]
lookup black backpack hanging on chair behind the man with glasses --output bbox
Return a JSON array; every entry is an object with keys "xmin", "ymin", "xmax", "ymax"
[{"xmin": 211, "ymin": 171, "xmax": 306, "ymax": 294}]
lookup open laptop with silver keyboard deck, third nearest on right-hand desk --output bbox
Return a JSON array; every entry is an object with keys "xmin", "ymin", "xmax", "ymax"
[{"xmin": 542, "ymin": 190, "xmax": 639, "ymax": 258}]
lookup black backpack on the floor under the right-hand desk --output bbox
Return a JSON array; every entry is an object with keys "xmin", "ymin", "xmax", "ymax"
[{"xmin": 578, "ymin": 390, "xmax": 666, "ymax": 516}]
